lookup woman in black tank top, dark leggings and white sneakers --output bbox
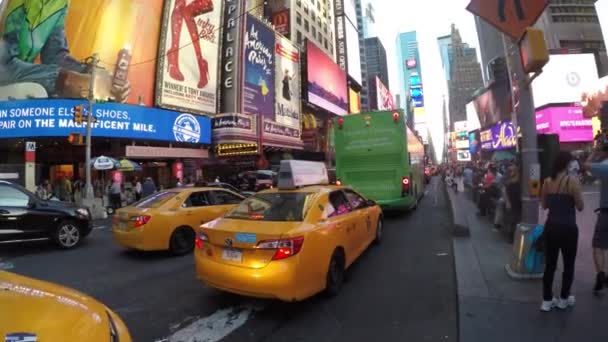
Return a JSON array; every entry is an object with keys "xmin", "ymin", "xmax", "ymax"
[{"xmin": 540, "ymin": 151, "xmax": 584, "ymax": 311}]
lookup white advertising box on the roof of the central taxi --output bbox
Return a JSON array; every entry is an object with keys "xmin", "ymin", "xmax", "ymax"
[{"xmin": 278, "ymin": 160, "xmax": 329, "ymax": 190}]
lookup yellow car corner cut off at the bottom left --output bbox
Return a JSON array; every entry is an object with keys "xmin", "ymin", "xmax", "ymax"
[{"xmin": 0, "ymin": 271, "xmax": 131, "ymax": 342}]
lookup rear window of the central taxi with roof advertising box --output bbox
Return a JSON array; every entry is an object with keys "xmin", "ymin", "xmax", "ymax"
[{"xmin": 225, "ymin": 192, "xmax": 314, "ymax": 222}]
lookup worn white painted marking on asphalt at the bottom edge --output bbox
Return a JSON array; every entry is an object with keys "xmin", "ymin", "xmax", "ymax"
[{"xmin": 156, "ymin": 304, "xmax": 263, "ymax": 342}]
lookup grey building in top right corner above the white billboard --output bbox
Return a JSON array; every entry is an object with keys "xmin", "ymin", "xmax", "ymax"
[{"xmin": 536, "ymin": 0, "xmax": 608, "ymax": 76}]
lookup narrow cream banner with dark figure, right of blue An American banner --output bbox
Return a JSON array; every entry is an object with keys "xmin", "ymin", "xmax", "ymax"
[{"xmin": 274, "ymin": 35, "xmax": 301, "ymax": 129}]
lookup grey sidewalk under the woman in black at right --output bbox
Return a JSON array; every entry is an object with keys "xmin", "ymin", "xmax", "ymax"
[{"xmin": 447, "ymin": 189, "xmax": 608, "ymax": 342}]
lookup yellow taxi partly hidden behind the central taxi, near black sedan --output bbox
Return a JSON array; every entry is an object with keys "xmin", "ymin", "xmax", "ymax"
[{"xmin": 112, "ymin": 187, "xmax": 244, "ymax": 255}]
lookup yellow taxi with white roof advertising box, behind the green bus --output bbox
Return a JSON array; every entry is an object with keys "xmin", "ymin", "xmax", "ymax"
[{"xmin": 194, "ymin": 160, "xmax": 383, "ymax": 301}]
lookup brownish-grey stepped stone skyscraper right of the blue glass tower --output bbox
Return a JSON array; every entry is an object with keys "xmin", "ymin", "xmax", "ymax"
[{"xmin": 448, "ymin": 24, "xmax": 483, "ymax": 131}]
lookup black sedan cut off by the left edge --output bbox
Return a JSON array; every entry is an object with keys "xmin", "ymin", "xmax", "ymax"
[{"xmin": 0, "ymin": 181, "xmax": 92, "ymax": 249}]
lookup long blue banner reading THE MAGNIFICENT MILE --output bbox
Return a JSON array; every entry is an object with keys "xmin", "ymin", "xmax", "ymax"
[{"xmin": 0, "ymin": 99, "xmax": 211, "ymax": 144}]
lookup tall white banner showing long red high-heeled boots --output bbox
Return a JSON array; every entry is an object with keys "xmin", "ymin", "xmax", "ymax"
[{"xmin": 156, "ymin": 0, "xmax": 222, "ymax": 114}]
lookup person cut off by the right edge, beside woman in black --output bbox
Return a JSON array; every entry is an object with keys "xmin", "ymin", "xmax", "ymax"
[{"xmin": 585, "ymin": 146, "xmax": 608, "ymax": 293}]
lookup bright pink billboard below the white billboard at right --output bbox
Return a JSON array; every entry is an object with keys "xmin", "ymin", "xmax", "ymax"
[{"xmin": 536, "ymin": 106, "xmax": 593, "ymax": 142}]
